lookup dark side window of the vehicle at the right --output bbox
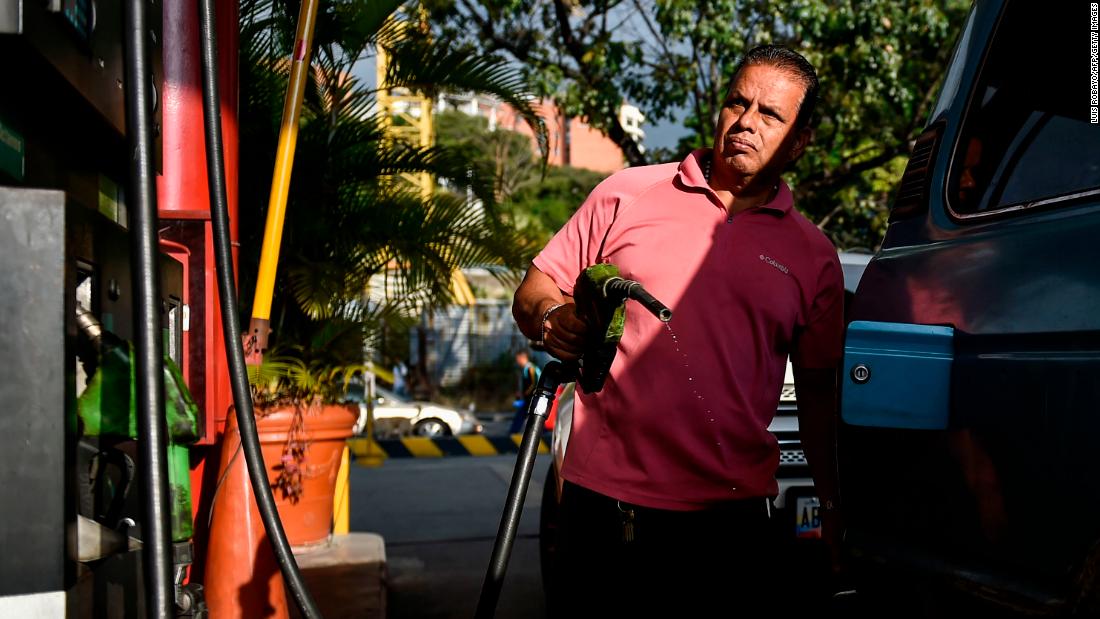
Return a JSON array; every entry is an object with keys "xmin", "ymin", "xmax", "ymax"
[{"xmin": 948, "ymin": 1, "xmax": 1100, "ymax": 218}]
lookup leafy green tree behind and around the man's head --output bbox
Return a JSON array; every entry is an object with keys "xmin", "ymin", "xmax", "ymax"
[{"xmin": 431, "ymin": 0, "xmax": 969, "ymax": 246}]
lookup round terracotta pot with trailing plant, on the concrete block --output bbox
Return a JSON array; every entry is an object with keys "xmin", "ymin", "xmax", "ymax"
[{"xmin": 256, "ymin": 405, "xmax": 359, "ymax": 546}]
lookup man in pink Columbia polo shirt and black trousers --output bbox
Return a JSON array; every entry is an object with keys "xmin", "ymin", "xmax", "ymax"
[{"xmin": 513, "ymin": 46, "xmax": 844, "ymax": 617}]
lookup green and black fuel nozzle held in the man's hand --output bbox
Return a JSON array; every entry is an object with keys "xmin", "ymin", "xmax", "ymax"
[{"xmin": 573, "ymin": 264, "xmax": 672, "ymax": 394}]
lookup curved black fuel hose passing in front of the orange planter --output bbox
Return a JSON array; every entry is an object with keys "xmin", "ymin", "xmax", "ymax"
[{"xmin": 198, "ymin": 0, "xmax": 321, "ymax": 619}]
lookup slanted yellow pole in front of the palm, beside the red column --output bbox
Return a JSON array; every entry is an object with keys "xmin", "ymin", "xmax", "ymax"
[{"xmin": 249, "ymin": 0, "xmax": 318, "ymax": 352}]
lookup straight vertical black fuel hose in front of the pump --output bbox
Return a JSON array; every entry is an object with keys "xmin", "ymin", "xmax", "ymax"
[{"xmin": 122, "ymin": 0, "xmax": 176, "ymax": 619}]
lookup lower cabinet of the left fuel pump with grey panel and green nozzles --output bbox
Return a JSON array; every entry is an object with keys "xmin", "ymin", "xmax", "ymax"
[{"xmin": 0, "ymin": 187, "xmax": 191, "ymax": 618}]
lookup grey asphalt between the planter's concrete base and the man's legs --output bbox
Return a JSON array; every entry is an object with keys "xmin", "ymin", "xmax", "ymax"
[{"xmin": 351, "ymin": 454, "xmax": 550, "ymax": 619}]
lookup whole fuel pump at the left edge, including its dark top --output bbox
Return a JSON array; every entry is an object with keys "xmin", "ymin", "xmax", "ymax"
[{"xmin": 0, "ymin": 0, "xmax": 229, "ymax": 618}]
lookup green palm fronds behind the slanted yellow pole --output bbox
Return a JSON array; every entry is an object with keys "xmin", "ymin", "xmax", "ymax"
[{"xmin": 240, "ymin": 0, "xmax": 545, "ymax": 364}]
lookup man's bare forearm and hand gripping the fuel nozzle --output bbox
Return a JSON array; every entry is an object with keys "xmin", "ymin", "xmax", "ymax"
[{"xmin": 512, "ymin": 266, "xmax": 589, "ymax": 361}]
